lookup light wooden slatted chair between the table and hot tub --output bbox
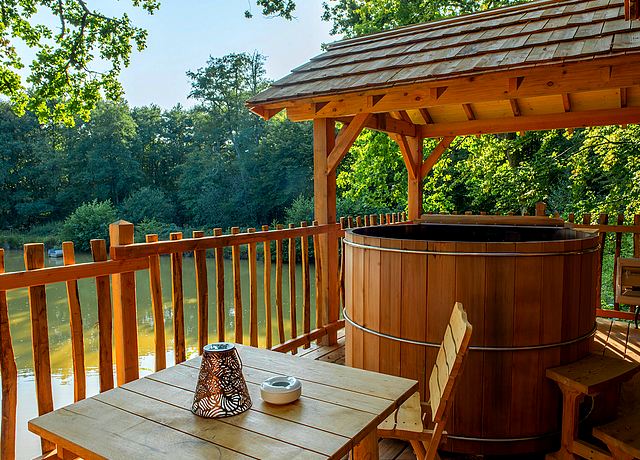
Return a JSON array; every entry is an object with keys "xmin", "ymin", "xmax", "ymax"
[{"xmin": 378, "ymin": 302, "xmax": 472, "ymax": 460}]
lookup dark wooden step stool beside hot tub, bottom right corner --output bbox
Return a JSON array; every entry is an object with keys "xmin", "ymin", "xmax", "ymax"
[{"xmin": 546, "ymin": 354, "xmax": 640, "ymax": 459}]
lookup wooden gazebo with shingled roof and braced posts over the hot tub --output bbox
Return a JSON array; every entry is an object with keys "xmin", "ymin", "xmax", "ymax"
[{"xmin": 247, "ymin": 0, "xmax": 640, "ymax": 342}]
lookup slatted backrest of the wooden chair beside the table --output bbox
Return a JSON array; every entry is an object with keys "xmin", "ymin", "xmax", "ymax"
[{"xmin": 429, "ymin": 302, "xmax": 472, "ymax": 422}]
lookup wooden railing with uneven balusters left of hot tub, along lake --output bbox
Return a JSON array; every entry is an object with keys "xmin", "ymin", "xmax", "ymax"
[{"xmin": 0, "ymin": 213, "xmax": 404, "ymax": 460}]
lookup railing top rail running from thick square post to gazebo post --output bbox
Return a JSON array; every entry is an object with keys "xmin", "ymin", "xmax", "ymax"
[{"xmin": 111, "ymin": 224, "xmax": 342, "ymax": 260}]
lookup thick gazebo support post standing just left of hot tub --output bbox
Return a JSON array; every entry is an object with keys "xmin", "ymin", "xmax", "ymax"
[{"xmin": 313, "ymin": 118, "xmax": 340, "ymax": 344}]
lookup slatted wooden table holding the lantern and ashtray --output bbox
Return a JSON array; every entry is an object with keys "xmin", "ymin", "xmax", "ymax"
[{"xmin": 29, "ymin": 345, "xmax": 418, "ymax": 459}]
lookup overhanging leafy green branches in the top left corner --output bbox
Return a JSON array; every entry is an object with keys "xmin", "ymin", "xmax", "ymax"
[{"xmin": 0, "ymin": 0, "xmax": 159, "ymax": 125}]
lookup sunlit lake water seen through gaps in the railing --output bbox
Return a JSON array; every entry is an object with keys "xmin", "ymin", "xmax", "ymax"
[{"xmin": 0, "ymin": 250, "xmax": 315, "ymax": 458}]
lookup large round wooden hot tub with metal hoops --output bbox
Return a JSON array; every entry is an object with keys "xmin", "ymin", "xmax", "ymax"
[{"xmin": 345, "ymin": 220, "xmax": 599, "ymax": 455}]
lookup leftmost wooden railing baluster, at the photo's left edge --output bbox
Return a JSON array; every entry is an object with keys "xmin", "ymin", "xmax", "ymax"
[{"xmin": 0, "ymin": 248, "xmax": 18, "ymax": 460}]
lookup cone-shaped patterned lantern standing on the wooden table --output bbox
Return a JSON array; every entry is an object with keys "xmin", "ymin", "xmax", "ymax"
[{"xmin": 191, "ymin": 342, "xmax": 251, "ymax": 418}]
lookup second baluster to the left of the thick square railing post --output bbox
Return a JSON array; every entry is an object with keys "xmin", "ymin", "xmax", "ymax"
[{"xmin": 62, "ymin": 241, "xmax": 87, "ymax": 402}]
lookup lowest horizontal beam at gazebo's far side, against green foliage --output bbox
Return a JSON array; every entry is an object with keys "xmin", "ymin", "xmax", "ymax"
[{"xmin": 420, "ymin": 107, "xmax": 640, "ymax": 138}]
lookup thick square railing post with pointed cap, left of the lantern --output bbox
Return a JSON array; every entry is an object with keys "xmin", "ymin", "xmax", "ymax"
[{"xmin": 109, "ymin": 220, "xmax": 139, "ymax": 385}]
